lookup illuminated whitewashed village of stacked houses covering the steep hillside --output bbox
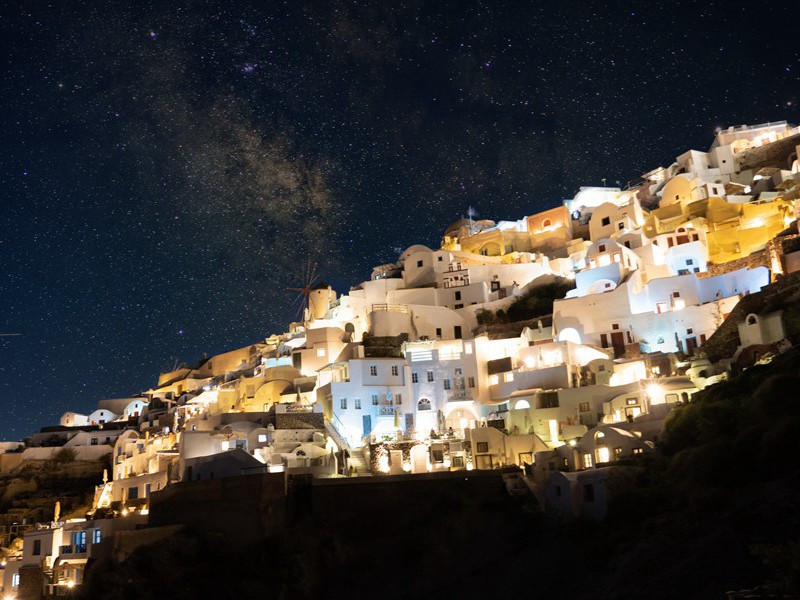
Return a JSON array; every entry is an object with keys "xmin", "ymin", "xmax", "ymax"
[{"xmin": 0, "ymin": 122, "xmax": 800, "ymax": 599}]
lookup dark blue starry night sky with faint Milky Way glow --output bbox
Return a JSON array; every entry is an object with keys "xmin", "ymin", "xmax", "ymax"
[{"xmin": 0, "ymin": 0, "xmax": 800, "ymax": 439}]
